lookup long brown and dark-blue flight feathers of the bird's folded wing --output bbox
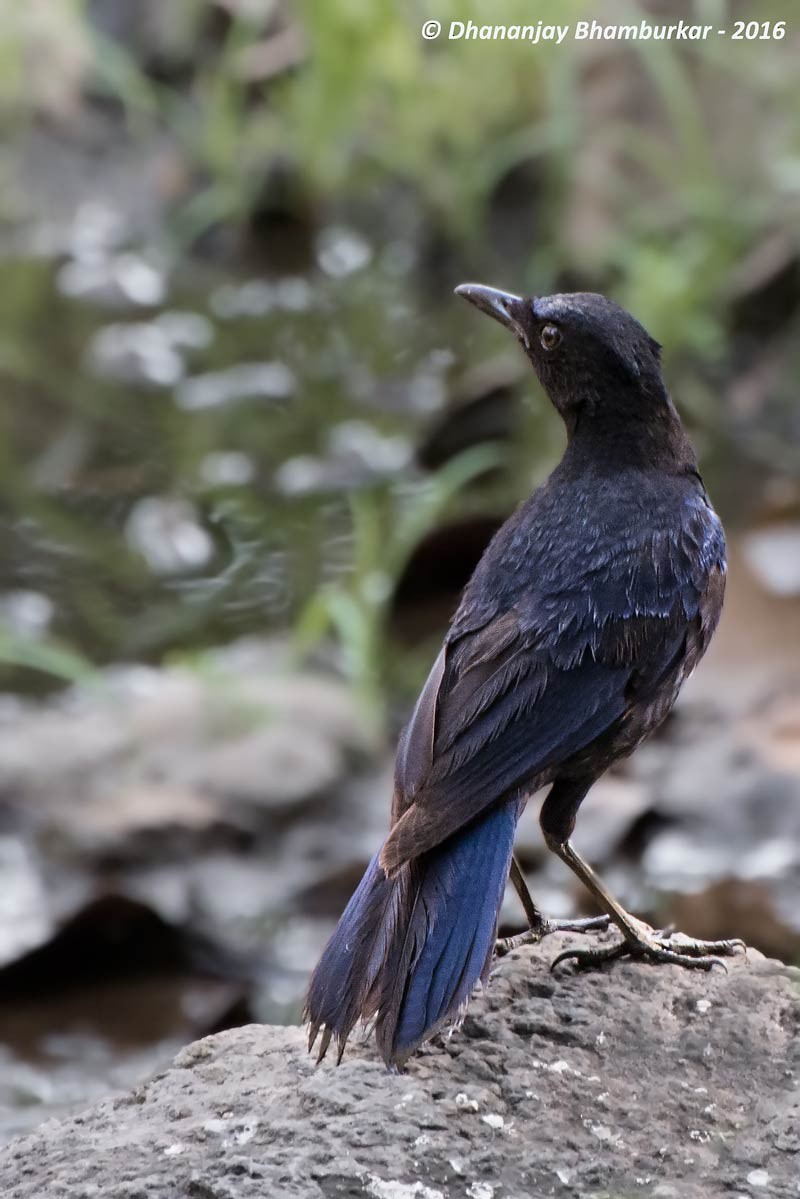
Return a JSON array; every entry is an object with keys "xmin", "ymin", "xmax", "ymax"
[{"xmin": 381, "ymin": 611, "xmax": 630, "ymax": 872}]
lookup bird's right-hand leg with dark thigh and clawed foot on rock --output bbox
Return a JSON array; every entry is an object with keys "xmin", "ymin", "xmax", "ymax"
[{"xmin": 540, "ymin": 779, "xmax": 746, "ymax": 970}]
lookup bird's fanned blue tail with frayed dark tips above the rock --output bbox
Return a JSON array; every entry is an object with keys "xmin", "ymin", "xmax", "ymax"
[{"xmin": 305, "ymin": 801, "xmax": 521, "ymax": 1065}]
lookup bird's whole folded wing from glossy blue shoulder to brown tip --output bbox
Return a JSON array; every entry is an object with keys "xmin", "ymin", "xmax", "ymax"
[{"xmin": 380, "ymin": 496, "xmax": 724, "ymax": 874}]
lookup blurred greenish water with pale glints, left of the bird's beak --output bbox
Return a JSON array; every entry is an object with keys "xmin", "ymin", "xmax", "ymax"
[{"xmin": 0, "ymin": 209, "xmax": 549, "ymax": 689}]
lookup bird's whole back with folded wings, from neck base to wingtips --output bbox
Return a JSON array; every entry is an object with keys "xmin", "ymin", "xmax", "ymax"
[{"xmin": 381, "ymin": 453, "xmax": 726, "ymax": 868}]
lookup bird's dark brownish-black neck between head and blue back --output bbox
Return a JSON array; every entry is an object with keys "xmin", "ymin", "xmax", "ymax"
[{"xmin": 565, "ymin": 381, "xmax": 697, "ymax": 472}]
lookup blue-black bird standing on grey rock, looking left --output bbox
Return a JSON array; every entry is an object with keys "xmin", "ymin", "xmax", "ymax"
[{"xmin": 306, "ymin": 283, "xmax": 741, "ymax": 1066}]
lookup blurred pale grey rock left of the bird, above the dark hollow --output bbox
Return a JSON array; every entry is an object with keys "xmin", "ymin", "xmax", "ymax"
[{"xmin": 0, "ymin": 638, "xmax": 383, "ymax": 968}]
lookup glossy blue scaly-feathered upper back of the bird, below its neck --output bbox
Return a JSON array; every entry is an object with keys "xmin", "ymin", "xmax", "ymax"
[{"xmin": 447, "ymin": 454, "xmax": 726, "ymax": 658}]
